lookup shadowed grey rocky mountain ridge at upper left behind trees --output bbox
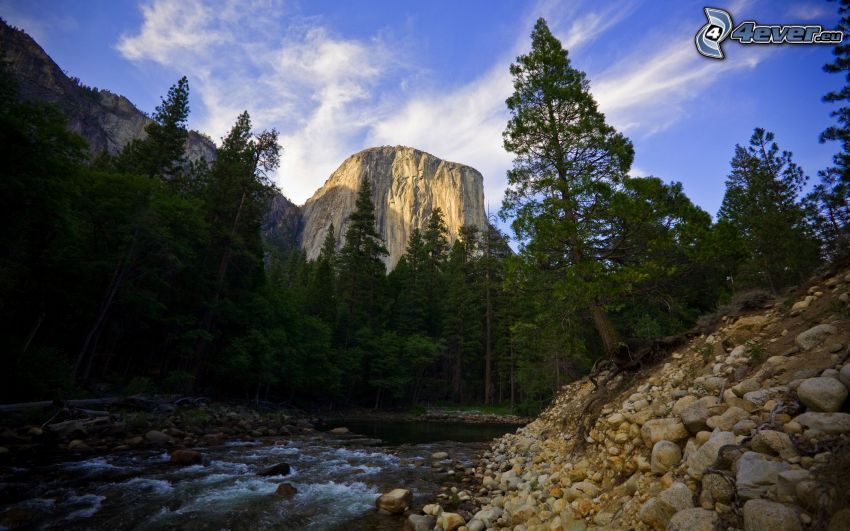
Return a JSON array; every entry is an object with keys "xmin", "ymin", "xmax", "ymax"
[{"xmin": 0, "ymin": 19, "xmax": 216, "ymax": 160}]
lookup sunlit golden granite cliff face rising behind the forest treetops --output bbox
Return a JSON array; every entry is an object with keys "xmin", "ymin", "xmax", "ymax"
[{"xmin": 301, "ymin": 146, "xmax": 487, "ymax": 268}]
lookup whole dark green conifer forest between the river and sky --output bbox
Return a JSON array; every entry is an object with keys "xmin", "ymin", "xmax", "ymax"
[{"xmin": 0, "ymin": 15, "xmax": 850, "ymax": 414}]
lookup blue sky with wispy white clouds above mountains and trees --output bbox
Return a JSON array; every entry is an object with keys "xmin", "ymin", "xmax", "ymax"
[{"xmin": 0, "ymin": 0, "xmax": 843, "ymax": 220}]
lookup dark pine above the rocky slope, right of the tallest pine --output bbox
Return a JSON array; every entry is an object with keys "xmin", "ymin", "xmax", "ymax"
[{"xmin": 718, "ymin": 128, "xmax": 817, "ymax": 292}]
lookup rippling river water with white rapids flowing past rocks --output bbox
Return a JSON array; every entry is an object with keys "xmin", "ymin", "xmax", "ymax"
[{"xmin": 0, "ymin": 422, "xmax": 516, "ymax": 531}]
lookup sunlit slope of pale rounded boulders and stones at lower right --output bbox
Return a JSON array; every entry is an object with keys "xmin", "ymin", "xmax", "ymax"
[{"xmin": 406, "ymin": 271, "xmax": 850, "ymax": 531}]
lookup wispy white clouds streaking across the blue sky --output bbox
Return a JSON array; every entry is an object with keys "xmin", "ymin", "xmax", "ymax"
[{"xmin": 117, "ymin": 0, "xmax": 772, "ymax": 209}]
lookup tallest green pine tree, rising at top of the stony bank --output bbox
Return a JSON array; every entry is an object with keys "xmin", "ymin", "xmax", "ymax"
[{"xmin": 503, "ymin": 19, "xmax": 634, "ymax": 354}]
